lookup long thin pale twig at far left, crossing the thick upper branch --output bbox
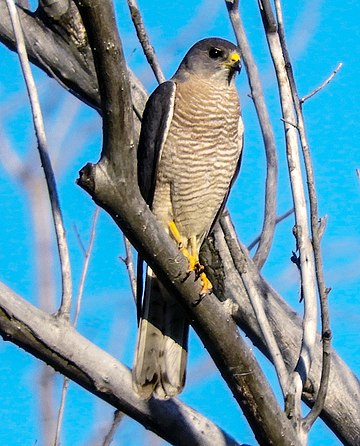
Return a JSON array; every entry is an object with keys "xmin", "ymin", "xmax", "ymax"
[{"xmin": 6, "ymin": 0, "xmax": 72, "ymax": 319}]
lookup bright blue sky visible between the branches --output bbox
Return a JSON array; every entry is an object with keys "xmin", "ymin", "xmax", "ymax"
[{"xmin": 0, "ymin": 0, "xmax": 360, "ymax": 446}]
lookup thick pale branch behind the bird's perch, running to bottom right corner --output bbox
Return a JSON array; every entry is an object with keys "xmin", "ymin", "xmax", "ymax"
[{"xmin": 202, "ymin": 218, "xmax": 360, "ymax": 445}]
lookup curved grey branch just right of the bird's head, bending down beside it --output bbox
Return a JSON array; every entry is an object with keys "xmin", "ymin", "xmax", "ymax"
[{"xmin": 225, "ymin": 0, "xmax": 278, "ymax": 269}]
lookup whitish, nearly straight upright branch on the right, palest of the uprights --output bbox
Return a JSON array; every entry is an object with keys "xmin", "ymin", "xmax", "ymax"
[{"xmin": 260, "ymin": 0, "xmax": 317, "ymax": 437}]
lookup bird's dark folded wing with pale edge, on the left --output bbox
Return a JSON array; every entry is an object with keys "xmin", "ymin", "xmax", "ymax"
[{"xmin": 138, "ymin": 81, "xmax": 176, "ymax": 208}]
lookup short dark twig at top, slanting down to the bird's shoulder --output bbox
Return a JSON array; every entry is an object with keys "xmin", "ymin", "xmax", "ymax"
[{"xmin": 127, "ymin": 0, "xmax": 165, "ymax": 84}]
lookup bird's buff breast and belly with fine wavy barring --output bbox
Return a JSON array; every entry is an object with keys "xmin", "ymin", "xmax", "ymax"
[{"xmin": 153, "ymin": 80, "xmax": 241, "ymax": 244}]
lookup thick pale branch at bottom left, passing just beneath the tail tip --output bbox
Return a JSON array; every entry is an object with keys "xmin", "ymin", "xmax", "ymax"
[{"xmin": 0, "ymin": 283, "xmax": 242, "ymax": 446}]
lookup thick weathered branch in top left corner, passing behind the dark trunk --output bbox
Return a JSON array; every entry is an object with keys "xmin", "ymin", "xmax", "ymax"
[{"xmin": 0, "ymin": 0, "xmax": 147, "ymax": 138}]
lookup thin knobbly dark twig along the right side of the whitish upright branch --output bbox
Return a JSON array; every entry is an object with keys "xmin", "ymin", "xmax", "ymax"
[{"xmin": 275, "ymin": 0, "xmax": 331, "ymax": 431}]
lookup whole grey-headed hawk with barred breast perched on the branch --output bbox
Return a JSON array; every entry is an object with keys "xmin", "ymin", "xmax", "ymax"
[{"xmin": 132, "ymin": 37, "xmax": 244, "ymax": 400}]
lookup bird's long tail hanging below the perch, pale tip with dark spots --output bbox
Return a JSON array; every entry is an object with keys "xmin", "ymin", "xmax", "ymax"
[{"xmin": 132, "ymin": 267, "xmax": 189, "ymax": 399}]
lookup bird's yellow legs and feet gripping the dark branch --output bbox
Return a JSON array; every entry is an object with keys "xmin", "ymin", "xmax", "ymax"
[{"xmin": 169, "ymin": 220, "xmax": 212, "ymax": 296}]
